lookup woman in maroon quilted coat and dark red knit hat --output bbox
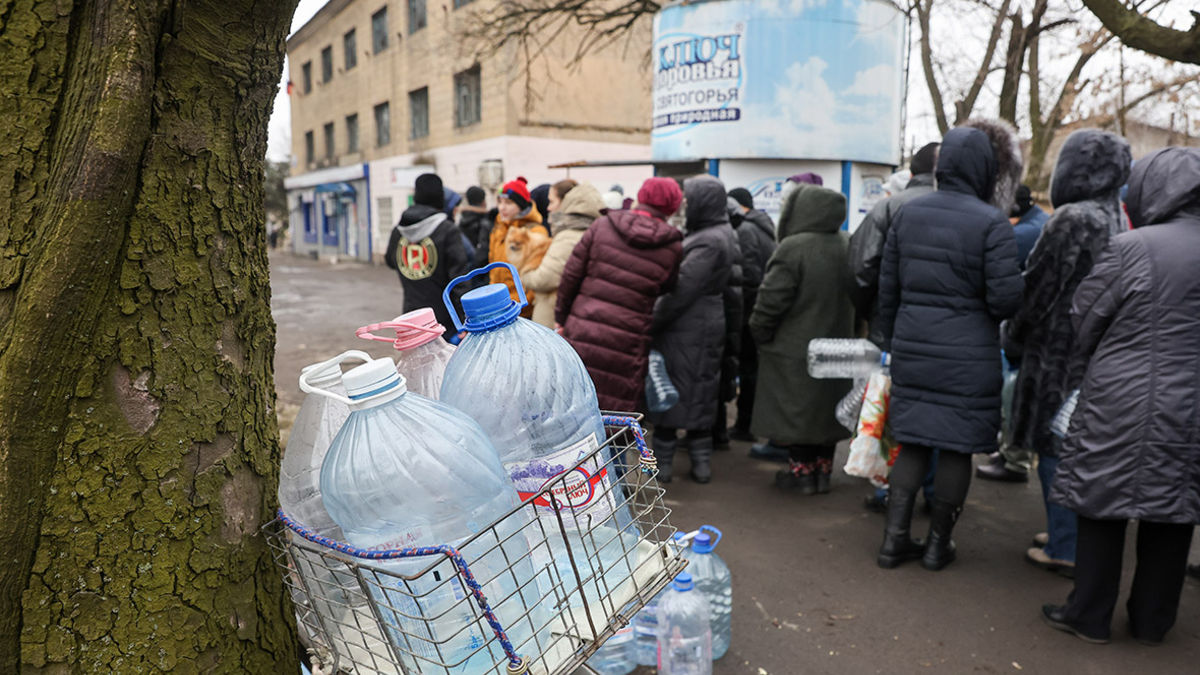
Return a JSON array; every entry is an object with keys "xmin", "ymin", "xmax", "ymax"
[{"xmin": 554, "ymin": 178, "xmax": 683, "ymax": 411}]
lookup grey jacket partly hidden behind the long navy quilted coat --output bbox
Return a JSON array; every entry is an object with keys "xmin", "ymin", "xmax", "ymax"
[{"xmin": 850, "ymin": 173, "xmax": 934, "ymax": 345}]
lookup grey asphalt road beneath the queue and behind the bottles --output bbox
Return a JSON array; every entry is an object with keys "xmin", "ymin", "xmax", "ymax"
[{"xmin": 271, "ymin": 253, "xmax": 1200, "ymax": 675}]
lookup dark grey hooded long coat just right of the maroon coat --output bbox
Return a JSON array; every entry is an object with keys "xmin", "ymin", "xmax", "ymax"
[{"xmin": 650, "ymin": 175, "xmax": 742, "ymax": 429}]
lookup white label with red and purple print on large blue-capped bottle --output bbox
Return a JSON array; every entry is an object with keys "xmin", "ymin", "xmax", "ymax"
[{"xmin": 504, "ymin": 434, "xmax": 617, "ymax": 528}]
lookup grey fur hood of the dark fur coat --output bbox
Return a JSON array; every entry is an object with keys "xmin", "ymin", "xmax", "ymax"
[{"xmin": 1050, "ymin": 129, "xmax": 1132, "ymax": 208}]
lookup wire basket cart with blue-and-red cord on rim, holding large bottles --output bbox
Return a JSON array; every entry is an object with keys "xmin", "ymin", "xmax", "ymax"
[{"xmin": 263, "ymin": 414, "xmax": 686, "ymax": 675}]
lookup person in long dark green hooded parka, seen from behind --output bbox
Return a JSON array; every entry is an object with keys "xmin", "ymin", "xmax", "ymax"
[{"xmin": 750, "ymin": 185, "xmax": 854, "ymax": 495}]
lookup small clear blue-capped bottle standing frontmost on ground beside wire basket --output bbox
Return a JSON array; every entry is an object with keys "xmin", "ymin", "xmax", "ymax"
[{"xmin": 659, "ymin": 572, "xmax": 713, "ymax": 675}]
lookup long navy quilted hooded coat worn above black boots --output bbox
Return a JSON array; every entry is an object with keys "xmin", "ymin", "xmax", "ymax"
[{"xmin": 878, "ymin": 127, "xmax": 1021, "ymax": 453}]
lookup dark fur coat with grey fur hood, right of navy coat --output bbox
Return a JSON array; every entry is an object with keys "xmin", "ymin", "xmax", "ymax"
[{"xmin": 1004, "ymin": 129, "xmax": 1130, "ymax": 456}]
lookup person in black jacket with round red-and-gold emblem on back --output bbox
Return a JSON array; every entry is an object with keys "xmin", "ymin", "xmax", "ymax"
[{"xmin": 384, "ymin": 173, "xmax": 469, "ymax": 340}]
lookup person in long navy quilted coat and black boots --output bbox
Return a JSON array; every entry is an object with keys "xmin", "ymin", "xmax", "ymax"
[{"xmin": 878, "ymin": 121, "xmax": 1022, "ymax": 569}]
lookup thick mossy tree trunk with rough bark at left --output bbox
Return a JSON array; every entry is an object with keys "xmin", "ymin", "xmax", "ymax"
[{"xmin": 0, "ymin": 0, "xmax": 296, "ymax": 673}]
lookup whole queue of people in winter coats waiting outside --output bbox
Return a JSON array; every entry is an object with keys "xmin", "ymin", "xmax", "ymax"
[{"xmin": 386, "ymin": 120, "xmax": 1200, "ymax": 644}]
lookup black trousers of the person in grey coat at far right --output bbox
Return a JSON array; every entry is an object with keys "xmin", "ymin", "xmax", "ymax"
[{"xmin": 1067, "ymin": 515, "xmax": 1193, "ymax": 641}]
